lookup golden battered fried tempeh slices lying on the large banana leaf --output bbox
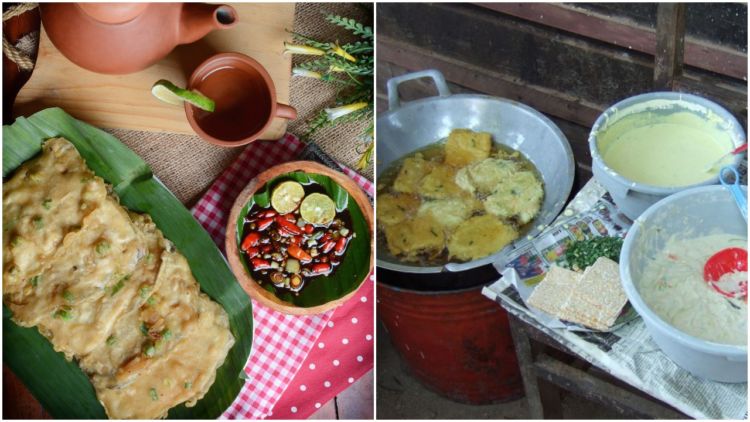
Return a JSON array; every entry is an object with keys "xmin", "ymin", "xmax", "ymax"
[{"xmin": 3, "ymin": 138, "xmax": 234, "ymax": 419}]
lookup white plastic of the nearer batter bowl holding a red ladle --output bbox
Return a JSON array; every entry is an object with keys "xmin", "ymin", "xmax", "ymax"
[{"xmin": 620, "ymin": 186, "xmax": 747, "ymax": 383}]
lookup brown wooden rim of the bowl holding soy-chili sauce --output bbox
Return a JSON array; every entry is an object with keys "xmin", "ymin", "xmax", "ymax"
[{"xmin": 225, "ymin": 161, "xmax": 374, "ymax": 315}]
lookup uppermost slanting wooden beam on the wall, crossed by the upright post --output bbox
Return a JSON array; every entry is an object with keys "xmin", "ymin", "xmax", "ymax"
[{"xmin": 477, "ymin": 3, "xmax": 747, "ymax": 81}]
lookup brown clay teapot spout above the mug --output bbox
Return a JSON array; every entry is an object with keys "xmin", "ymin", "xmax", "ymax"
[{"xmin": 179, "ymin": 3, "xmax": 237, "ymax": 44}]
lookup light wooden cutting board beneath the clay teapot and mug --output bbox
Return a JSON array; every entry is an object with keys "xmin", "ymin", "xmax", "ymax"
[{"xmin": 13, "ymin": 3, "xmax": 294, "ymax": 139}]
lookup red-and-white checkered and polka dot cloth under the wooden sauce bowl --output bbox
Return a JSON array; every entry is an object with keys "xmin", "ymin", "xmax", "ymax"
[{"xmin": 192, "ymin": 134, "xmax": 374, "ymax": 419}]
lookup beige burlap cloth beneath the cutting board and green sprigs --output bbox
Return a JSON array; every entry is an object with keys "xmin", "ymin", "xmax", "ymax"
[{"xmin": 106, "ymin": 3, "xmax": 373, "ymax": 206}]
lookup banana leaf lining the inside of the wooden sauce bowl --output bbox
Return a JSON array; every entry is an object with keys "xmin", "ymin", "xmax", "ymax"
[{"xmin": 236, "ymin": 171, "xmax": 370, "ymax": 308}]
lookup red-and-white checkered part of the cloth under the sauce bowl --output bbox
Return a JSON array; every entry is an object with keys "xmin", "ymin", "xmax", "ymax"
[{"xmin": 192, "ymin": 134, "xmax": 373, "ymax": 419}]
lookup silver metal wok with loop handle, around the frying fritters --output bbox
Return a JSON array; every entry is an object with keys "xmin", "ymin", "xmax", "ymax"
[{"xmin": 377, "ymin": 70, "xmax": 574, "ymax": 287}]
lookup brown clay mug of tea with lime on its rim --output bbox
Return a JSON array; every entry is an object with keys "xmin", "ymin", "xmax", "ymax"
[{"xmin": 185, "ymin": 53, "xmax": 297, "ymax": 147}]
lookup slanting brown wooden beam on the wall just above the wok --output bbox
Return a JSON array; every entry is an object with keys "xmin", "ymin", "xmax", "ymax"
[{"xmin": 378, "ymin": 35, "xmax": 606, "ymax": 127}]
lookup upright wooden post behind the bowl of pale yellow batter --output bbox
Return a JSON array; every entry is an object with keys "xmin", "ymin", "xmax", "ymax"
[{"xmin": 654, "ymin": 3, "xmax": 685, "ymax": 91}]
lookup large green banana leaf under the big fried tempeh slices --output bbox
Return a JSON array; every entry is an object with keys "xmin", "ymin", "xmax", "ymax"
[{"xmin": 3, "ymin": 108, "xmax": 253, "ymax": 419}]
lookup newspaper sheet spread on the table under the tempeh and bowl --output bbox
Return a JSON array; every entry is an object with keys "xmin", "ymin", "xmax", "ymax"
[{"xmin": 483, "ymin": 177, "xmax": 747, "ymax": 419}]
